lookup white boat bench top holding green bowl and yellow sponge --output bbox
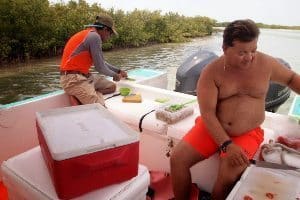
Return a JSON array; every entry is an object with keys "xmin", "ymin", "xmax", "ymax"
[{"xmin": 104, "ymin": 83, "xmax": 199, "ymax": 136}]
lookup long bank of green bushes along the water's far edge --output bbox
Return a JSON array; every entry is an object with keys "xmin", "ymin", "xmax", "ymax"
[{"xmin": 0, "ymin": 0, "xmax": 216, "ymax": 62}]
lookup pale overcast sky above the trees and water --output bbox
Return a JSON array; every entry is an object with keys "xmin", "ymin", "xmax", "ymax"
[{"xmin": 50, "ymin": 0, "xmax": 300, "ymax": 26}]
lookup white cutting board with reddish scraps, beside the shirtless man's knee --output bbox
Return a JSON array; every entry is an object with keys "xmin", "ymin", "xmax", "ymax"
[{"xmin": 232, "ymin": 166, "xmax": 300, "ymax": 200}]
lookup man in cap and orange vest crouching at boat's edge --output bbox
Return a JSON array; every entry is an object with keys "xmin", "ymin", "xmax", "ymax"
[{"xmin": 60, "ymin": 14, "xmax": 127, "ymax": 105}]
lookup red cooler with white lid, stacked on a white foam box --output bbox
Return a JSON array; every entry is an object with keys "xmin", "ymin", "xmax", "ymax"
[{"xmin": 37, "ymin": 104, "xmax": 139, "ymax": 199}]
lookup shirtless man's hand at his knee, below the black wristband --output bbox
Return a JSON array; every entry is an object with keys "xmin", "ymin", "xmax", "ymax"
[{"xmin": 226, "ymin": 143, "xmax": 250, "ymax": 166}]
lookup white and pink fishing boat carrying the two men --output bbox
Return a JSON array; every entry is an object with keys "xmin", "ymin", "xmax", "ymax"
[{"xmin": 0, "ymin": 65, "xmax": 300, "ymax": 199}]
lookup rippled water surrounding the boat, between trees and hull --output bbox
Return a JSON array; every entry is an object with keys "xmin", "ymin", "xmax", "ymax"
[{"xmin": 0, "ymin": 29, "xmax": 300, "ymax": 114}]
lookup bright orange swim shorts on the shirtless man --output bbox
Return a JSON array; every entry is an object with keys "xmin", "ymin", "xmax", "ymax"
[{"xmin": 183, "ymin": 116, "xmax": 264, "ymax": 159}]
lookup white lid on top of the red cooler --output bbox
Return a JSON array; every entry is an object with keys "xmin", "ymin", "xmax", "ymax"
[{"xmin": 36, "ymin": 104, "xmax": 138, "ymax": 160}]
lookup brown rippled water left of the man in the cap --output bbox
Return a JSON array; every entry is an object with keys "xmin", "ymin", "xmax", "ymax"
[{"xmin": 0, "ymin": 62, "xmax": 59, "ymax": 104}]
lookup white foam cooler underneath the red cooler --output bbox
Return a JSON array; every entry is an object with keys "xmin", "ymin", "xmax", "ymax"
[{"xmin": 2, "ymin": 146, "xmax": 150, "ymax": 200}]
